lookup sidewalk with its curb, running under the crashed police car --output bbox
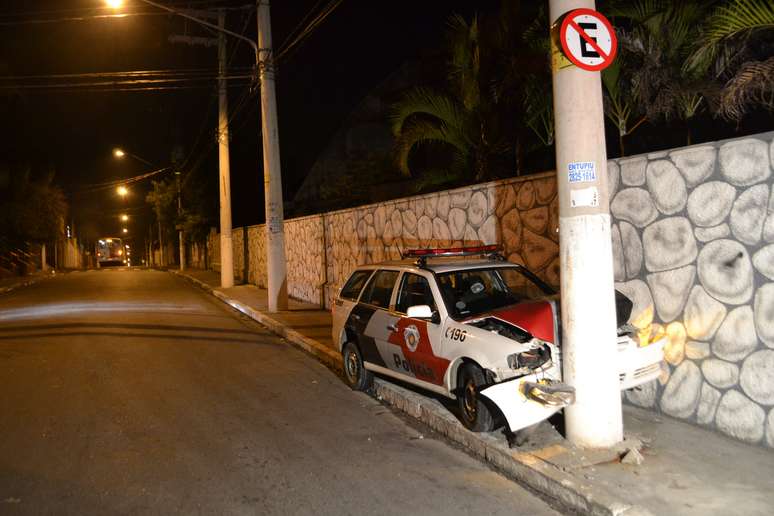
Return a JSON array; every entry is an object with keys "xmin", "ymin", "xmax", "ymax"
[{"xmin": 176, "ymin": 270, "xmax": 774, "ymax": 516}]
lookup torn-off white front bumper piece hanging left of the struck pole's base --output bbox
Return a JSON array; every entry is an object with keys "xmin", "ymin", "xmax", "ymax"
[{"xmin": 480, "ymin": 373, "xmax": 575, "ymax": 432}]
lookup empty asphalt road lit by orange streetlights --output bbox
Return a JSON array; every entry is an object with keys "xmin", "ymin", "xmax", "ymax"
[{"xmin": 0, "ymin": 269, "xmax": 556, "ymax": 515}]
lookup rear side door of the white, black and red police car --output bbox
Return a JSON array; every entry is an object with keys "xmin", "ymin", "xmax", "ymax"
[{"xmin": 347, "ymin": 269, "xmax": 400, "ymax": 369}]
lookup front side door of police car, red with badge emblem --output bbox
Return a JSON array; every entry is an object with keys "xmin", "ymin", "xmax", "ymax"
[{"xmin": 388, "ymin": 272, "xmax": 449, "ymax": 386}]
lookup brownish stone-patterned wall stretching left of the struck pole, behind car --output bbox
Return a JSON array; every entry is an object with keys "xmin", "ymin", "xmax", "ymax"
[{"xmin": 203, "ymin": 173, "xmax": 559, "ymax": 306}]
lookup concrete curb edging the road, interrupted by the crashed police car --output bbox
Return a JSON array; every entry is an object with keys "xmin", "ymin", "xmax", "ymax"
[{"xmin": 174, "ymin": 271, "xmax": 651, "ymax": 516}]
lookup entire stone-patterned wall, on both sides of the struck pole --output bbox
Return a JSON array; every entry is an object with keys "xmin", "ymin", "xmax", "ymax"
[{"xmin": 208, "ymin": 133, "xmax": 774, "ymax": 447}]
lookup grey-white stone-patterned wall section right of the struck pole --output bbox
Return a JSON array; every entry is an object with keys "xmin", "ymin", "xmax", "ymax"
[{"xmin": 610, "ymin": 133, "xmax": 774, "ymax": 447}]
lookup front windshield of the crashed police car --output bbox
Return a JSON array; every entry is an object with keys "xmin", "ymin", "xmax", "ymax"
[{"xmin": 437, "ymin": 267, "xmax": 555, "ymax": 319}]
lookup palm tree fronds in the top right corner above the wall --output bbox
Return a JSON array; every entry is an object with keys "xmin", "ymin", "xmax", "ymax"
[{"xmin": 683, "ymin": 0, "xmax": 774, "ymax": 121}]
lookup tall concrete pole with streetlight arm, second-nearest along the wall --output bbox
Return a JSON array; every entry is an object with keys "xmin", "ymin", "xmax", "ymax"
[{"xmin": 257, "ymin": 0, "xmax": 288, "ymax": 312}]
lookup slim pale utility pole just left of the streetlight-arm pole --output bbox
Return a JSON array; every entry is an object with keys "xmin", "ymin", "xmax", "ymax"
[{"xmin": 218, "ymin": 11, "xmax": 234, "ymax": 288}]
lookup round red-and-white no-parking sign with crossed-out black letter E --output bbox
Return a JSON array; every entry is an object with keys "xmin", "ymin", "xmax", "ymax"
[{"xmin": 559, "ymin": 9, "xmax": 618, "ymax": 72}]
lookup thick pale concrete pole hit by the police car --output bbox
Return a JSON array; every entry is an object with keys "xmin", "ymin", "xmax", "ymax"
[{"xmin": 549, "ymin": 0, "xmax": 623, "ymax": 447}]
